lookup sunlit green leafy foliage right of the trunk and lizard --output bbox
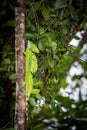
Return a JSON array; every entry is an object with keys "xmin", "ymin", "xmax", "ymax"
[{"xmin": 25, "ymin": 0, "xmax": 87, "ymax": 130}]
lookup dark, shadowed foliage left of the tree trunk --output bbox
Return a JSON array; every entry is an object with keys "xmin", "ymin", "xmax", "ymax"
[{"xmin": 0, "ymin": 0, "xmax": 16, "ymax": 129}]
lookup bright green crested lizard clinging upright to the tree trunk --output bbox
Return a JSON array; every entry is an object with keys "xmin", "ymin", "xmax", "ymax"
[{"xmin": 22, "ymin": 41, "xmax": 41, "ymax": 101}]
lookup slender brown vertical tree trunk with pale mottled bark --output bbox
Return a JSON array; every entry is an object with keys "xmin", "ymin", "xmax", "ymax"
[{"xmin": 14, "ymin": 0, "xmax": 26, "ymax": 130}]
